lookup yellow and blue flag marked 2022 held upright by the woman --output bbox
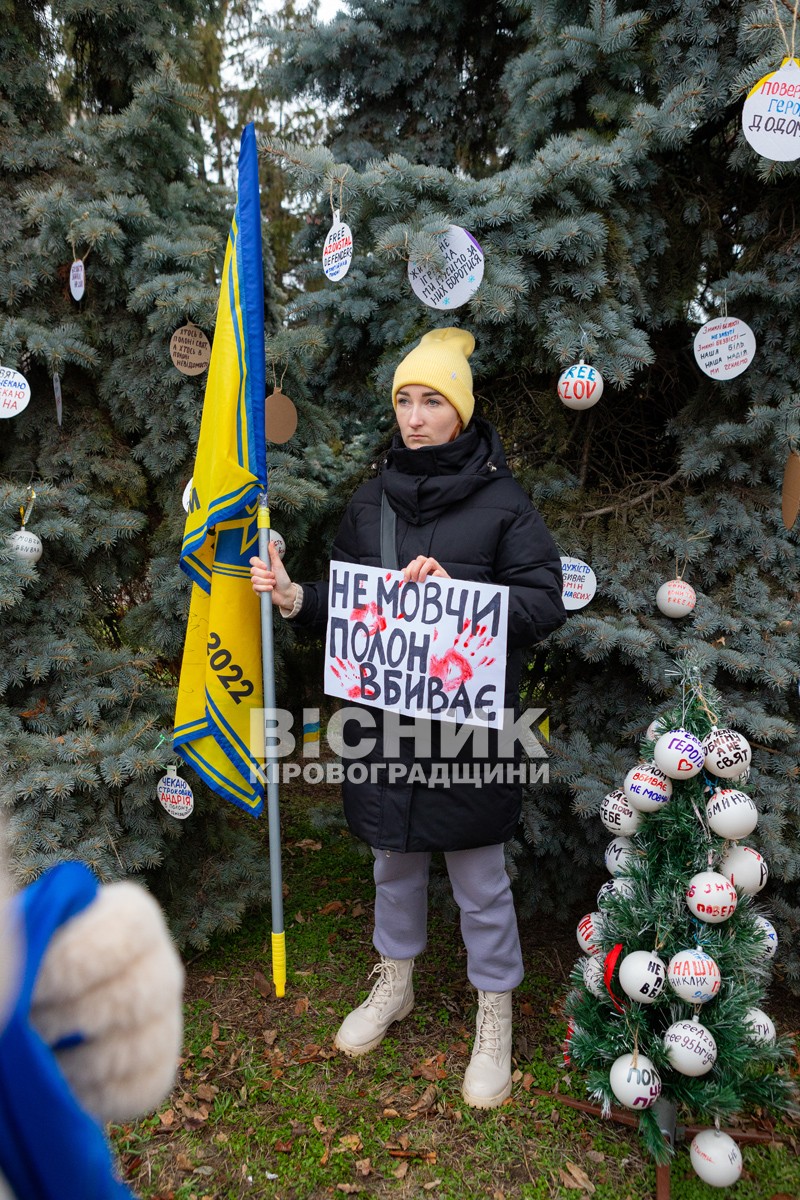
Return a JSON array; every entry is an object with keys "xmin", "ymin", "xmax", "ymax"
[{"xmin": 174, "ymin": 125, "xmax": 266, "ymax": 816}]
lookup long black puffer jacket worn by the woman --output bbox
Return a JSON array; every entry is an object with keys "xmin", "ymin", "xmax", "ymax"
[{"xmin": 295, "ymin": 419, "xmax": 566, "ymax": 851}]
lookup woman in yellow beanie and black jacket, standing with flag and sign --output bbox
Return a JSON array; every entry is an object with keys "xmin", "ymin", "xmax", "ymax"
[{"xmin": 251, "ymin": 329, "xmax": 565, "ymax": 1108}]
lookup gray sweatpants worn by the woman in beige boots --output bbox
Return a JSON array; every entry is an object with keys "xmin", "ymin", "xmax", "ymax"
[{"xmin": 373, "ymin": 845, "xmax": 524, "ymax": 991}]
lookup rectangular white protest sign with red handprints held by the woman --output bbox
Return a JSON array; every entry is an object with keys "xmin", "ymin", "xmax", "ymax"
[{"xmin": 325, "ymin": 562, "xmax": 509, "ymax": 730}]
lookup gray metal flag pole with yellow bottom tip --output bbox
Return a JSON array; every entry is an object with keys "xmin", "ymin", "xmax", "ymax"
[{"xmin": 258, "ymin": 491, "xmax": 287, "ymax": 996}]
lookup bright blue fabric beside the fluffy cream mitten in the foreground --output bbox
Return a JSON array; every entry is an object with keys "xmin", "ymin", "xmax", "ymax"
[{"xmin": 0, "ymin": 863, "xmax": 132, "ymax": 1200}]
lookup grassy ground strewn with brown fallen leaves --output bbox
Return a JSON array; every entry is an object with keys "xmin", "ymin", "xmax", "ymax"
[{"xmin": 113, "ymin": 796, "xmax": 800, "ymax": 1200}]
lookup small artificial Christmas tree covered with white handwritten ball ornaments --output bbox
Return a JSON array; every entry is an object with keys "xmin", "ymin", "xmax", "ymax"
[{"xmin": 566, "ymin": 659, "xmax": 792, "ymax": 1183}]
